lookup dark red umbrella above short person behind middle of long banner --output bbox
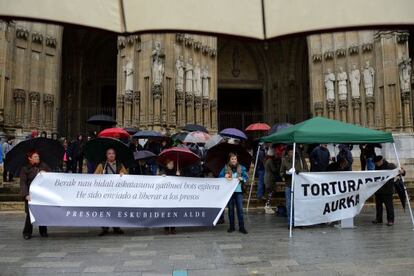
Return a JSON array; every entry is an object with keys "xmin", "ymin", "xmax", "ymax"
[{"xmin": 158, "ymin": 147, "xmax": 200, "ymax": 170}]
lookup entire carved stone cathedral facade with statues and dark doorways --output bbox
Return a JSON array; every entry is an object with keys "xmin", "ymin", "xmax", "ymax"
[{"xmin": 0, "ymin": 21, "xmax": 414, "ymax": 143}]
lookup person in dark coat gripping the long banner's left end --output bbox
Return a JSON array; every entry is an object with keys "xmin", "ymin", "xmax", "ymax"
[{"xmin": 20, "ymin": 151, "xmax": 50, "ymax": 240}]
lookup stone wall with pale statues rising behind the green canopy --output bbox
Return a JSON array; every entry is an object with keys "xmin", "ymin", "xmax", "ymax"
[{"xmin": 308, "ymin": 30, "xmax": 413, "ymax": 132}]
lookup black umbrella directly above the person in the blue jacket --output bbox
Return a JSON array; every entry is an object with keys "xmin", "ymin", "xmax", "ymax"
[{"xmin": 206, "ymin": 143, "xmax": 252, "ymax": 176}]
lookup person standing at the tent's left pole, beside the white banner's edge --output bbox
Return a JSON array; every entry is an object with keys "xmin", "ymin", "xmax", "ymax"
[{"xmin": 280, "ymin": 145, "xmax": 308, "ymax": 226}]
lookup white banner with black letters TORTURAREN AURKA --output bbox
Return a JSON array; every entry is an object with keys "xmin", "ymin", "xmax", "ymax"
[{"xmin": 288, "ymin": 169, "xmax": 398, "ymax": 226}]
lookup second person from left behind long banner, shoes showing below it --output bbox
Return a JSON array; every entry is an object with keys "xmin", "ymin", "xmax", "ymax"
[{"xmin": 95, "ymin": 148, "xmax": 127, "ymax": 236}]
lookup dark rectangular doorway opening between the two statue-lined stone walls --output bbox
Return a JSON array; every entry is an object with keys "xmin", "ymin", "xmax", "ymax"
[{"xmin": 217, "ymin": 89, "xmax": 263, "ymax": 130}]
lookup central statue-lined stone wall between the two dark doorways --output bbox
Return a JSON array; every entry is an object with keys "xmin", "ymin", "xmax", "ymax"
[{"xmin": 117, "ymin": 33, "xmax": 217, "ymax": 132}]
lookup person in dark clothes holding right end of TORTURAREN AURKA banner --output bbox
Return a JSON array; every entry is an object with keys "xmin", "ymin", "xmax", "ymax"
[{"xmin": 372, "ymin": 155, "xmax": 405, "ymax": 226}]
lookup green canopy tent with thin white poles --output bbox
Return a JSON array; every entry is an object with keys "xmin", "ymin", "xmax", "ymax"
[{"xmin": 261, "ymin": 117, "xmax": 414, "ymax": 237}]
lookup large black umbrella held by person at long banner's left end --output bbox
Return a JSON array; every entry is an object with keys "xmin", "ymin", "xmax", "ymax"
[{"xmin": 5, "ymin": 137, "xmax": 65, "ymax": 175}]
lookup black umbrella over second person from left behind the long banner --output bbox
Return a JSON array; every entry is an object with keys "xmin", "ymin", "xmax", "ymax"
[{"xmin": 83, "ymin": 137, "xmax": 135, "ymax": 168}]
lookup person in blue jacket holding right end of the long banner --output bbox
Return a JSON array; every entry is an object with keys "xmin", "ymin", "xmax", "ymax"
[{"xmin": 219, "ymin": 153, "xmax": 249, "ymax": 234}]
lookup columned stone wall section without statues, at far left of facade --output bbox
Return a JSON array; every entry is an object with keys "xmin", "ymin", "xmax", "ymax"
[{"xmin": 0, "ymin": 21, "xmax": 63, "ymax": 139}]
